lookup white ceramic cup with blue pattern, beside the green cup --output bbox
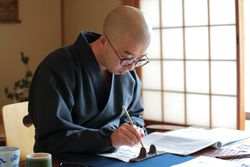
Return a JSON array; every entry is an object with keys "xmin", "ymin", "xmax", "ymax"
[{"xmin": 0, "ymin": 146, "xmax": 20, "ymax": 167}]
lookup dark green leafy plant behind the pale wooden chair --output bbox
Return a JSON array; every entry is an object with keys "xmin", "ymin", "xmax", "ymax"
[{"xmin": 4, "ymin": 52, "xmax": 33, "ymax": 102}]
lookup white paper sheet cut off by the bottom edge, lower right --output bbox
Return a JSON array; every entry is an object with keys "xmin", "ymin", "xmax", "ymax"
[{"xmin": 172, "ymin": 156, "xmax": 245, "ymax": 167}]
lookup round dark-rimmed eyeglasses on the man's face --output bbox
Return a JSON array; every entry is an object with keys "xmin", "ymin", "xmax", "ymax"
[{"xmin": 105, "ymin": 35, "xmax": 149, "ymax": 68}]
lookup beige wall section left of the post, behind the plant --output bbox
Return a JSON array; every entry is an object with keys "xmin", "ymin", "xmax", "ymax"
[{"xmin": 0, "ymin": 0, "xmax": 61, "ymax": 135}]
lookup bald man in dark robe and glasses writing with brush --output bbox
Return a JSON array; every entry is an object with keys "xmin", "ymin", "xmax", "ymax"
[{"xmin": 28, "ymin": 6, "xmax": 151, "ymax": 155}]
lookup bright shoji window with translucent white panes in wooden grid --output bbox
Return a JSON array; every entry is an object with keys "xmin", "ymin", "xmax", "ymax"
[{"xmin": 140, "ymin": 0, "xmax": 244, "ymax": 129}]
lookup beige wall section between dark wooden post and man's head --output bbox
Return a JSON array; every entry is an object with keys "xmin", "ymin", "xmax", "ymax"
[{"xmin": 64, "ymin": 0, "xmax": 122, "ymax": 45}]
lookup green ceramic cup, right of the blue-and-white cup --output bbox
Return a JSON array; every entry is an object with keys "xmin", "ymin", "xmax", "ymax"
[{"xmin": 25, "ymin": 153, "xmax": 52, "ymax": 167}]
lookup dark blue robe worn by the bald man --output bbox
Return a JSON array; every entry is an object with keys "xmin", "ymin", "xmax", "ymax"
[{"xmin": 29, "ymin": 32, "xmax": 145, "ymax": 154}]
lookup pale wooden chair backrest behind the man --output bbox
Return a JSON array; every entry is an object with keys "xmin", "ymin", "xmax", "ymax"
[{"xmin": 2, "ymin": 102, "xmax": 35, "ymax": 160}]
